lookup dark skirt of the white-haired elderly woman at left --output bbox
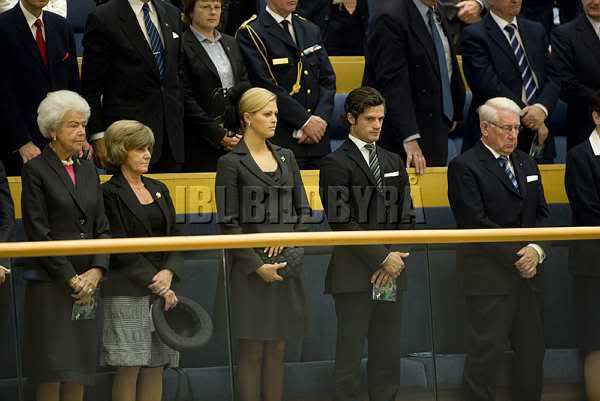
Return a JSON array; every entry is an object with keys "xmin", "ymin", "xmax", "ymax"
[{"xmin": 24, "ymin": 281, "xmax": 100, "ymax": 384}]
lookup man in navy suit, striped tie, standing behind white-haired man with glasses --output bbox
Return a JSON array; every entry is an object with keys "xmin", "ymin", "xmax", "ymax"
[{"xmin": 461, "ymin": 0, "xmax": 559, "ymax": 163}]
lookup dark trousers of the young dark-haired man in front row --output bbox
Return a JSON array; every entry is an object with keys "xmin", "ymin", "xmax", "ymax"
[{"xmin": 333, "ymin": 292, "xmax": 401, "ymax": 401}]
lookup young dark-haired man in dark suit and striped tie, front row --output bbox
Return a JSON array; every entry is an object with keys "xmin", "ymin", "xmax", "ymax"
[{"xmin": 319, "ymin": 87, "xmax": 412, "ymax": 401}]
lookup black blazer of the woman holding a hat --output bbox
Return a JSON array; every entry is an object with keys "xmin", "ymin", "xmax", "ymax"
[{"xmin": 102, "ymin": 172, "xmax": 183, "ymax": 296}]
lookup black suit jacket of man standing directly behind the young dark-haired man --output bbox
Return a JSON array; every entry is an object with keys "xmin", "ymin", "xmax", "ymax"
[{"xmin": 365, "ymin": 0, "xmax": 465, "ymax": 166}]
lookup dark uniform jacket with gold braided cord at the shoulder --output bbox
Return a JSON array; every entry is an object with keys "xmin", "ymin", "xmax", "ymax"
[{"xmin": 236, "ymin": 10, "xmax": 335, "ymax": 158}]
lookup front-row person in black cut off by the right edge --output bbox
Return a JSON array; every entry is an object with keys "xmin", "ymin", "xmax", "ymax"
[{"xmin": 565, "ymin": 90, "xmax": 600, "ymax": 401}]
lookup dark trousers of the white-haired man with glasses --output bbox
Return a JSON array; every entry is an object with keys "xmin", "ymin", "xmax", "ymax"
[{"xmin": 464, "ymin": 280, "xmax": 545, "ymax": 401}]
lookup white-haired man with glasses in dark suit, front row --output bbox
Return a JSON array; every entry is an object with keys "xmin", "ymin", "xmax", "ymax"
[{"xmin": 448, "ymin": 98, "xmax": 549, "ymax": 401}]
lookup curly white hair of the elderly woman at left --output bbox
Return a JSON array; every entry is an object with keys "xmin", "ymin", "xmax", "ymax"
[{"xmin": 37, "ymin": 90, "xmax": 90, "ymax": 139}]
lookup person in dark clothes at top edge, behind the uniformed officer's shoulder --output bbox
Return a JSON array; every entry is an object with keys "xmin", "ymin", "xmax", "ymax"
[{"xmin": 297, "ymin": 0, "xmax": 372, "ymax": 56}]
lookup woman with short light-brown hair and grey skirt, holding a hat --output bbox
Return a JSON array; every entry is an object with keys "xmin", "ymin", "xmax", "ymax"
[{"xmin": 101, "ymin": 120, "xmax": 183, "ymax": 401}]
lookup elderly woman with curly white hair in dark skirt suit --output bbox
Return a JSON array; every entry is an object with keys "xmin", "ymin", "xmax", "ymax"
[{"xmin": 21, "ymin": 90, "xmax": 110, "ymax": 401}]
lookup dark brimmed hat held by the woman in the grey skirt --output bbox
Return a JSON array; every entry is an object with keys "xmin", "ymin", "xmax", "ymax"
[{"xmin": 152, "ymin": 295, "xmax": 213, "ymax": 351}]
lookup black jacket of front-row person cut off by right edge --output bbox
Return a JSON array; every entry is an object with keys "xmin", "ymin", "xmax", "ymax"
[{"xmin": 565, "ymin": 134, "xmax": 600, "ymax": 276}]
